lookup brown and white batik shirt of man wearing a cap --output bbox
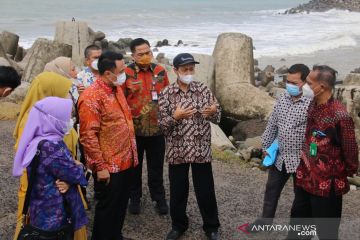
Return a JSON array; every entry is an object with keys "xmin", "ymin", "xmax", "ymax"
[{"xmin": 159, "ymin": 82, "xmax": 221, "ymax": 164}]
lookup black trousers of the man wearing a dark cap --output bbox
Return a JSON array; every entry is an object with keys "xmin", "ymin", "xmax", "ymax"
[{"xmin": 169, "ymin": 163, "xmax": 220, "ymax": 232}]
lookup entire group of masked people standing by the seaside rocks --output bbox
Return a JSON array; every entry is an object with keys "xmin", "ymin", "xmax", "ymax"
[{"xmin": 0, "ymin": 38, "xmax": 359, "ymax": 240}]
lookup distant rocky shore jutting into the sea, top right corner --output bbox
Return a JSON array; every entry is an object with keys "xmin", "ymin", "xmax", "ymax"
[{"xmin": 285, "ymin": 0, "xmax": 360, "ymax": 14}]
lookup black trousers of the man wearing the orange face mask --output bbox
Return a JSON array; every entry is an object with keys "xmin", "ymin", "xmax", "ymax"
[{"xmin": 130, "ymin": 135, "xmax": 165, "ymax": 203}]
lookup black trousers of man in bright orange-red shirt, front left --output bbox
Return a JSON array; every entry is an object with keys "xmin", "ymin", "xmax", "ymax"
[{"xmin": 92, "ymin": 168, "xmax": 134, "ymax": 240}]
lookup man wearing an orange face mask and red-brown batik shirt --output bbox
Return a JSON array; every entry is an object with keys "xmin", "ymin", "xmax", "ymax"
[{"xmin": 123, "ymin": 38, "xmax": 169, "ymax": 214}]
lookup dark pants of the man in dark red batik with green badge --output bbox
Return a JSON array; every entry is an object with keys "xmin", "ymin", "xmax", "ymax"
[{"xmin": 288, "ymin": 187, "xmax": 342, "ymax": 240}]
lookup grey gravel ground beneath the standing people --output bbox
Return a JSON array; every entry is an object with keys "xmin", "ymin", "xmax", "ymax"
[{"xmin": 0, "ymin": 121, "xmax": 360, "ymax": 240}]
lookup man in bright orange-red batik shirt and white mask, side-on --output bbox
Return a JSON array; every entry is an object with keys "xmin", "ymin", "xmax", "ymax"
[{"xmin": 78, "ymin": 52, "xmax": 138, "ymax": 240}]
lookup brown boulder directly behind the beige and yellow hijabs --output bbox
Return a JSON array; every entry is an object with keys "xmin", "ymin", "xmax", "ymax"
[{"xmin": 19, "ymin": 38, "xmax": 72, "ymax": 82}]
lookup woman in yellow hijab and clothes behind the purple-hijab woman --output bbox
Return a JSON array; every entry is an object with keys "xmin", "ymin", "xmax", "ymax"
[{"xmin": 14, "ymin": 72, "xmax": 87, "ymax": 240}]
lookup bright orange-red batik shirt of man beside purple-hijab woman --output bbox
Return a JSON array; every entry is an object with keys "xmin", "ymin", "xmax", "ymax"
[{"xmin": 78, "ymin": 79, "xmax": 138, "ymax": 173}]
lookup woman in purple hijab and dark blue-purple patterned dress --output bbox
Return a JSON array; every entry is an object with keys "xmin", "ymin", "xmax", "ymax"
[{"xmin": 13, "ymin": 97, "xmax": 88, "ymax": 231}]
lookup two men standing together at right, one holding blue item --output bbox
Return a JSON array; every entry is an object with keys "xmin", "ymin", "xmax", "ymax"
[{"xmin": 247, "ymin": 64, "xmax": 359, "ymax": 239}]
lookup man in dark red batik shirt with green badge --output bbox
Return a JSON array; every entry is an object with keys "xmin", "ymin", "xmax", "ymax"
[{"xmin": 289, "ymin": 65, "xmax": 359, "ymax": 239}]
